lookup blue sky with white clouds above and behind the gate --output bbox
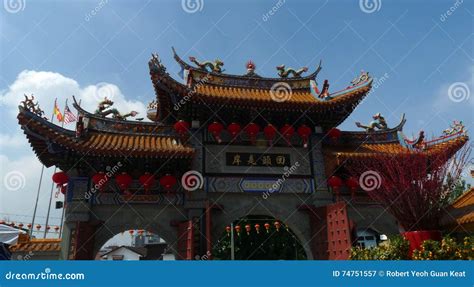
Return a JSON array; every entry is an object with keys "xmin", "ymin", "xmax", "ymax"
[{"xmin": 0, "ymin": 0, "xmax": 474, "ymax": 236}]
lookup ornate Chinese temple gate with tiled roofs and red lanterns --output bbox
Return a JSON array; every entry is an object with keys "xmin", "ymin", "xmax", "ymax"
[{"xmin": 18, "ymin": 49, "xmax": 467, "ymax": 259}]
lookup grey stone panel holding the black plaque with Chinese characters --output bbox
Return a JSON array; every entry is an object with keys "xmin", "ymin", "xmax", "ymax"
[{"xmin": 203, "ymin": 145, "xmax": 311, "ymax": 176}]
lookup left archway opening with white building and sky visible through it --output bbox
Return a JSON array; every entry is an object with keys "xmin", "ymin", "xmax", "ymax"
[{"xmin": 95, "ymin": 229, "xmax": 176, "ymax": 261}]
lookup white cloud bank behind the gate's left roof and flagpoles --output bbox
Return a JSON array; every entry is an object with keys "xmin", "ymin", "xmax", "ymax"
[{"xmin": 0, "ymin": 70, "xmax": 150, "ymax": 225}]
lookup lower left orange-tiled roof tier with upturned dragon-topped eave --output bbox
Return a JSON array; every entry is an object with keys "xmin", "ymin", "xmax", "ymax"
[{"xmin": 18, "ymin": 106, "xmax": 194, "ymax": 167}]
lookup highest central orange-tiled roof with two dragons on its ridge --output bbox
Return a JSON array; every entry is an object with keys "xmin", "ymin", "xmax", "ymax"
[{"xmin": 149, "ymin": 51, "xmax": 373, "ymax": 129}]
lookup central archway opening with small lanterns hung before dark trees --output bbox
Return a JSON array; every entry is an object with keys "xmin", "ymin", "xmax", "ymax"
[{"xmin": 212, "ymin": 215, "xmax": 307, "ymax": 260}]
